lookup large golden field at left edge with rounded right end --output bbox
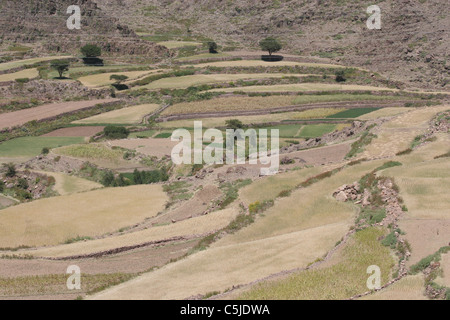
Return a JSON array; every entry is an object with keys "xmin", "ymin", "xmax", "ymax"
[{"xmin": 0, "ymin": 185, "xmax": 168, "ymax": 247}]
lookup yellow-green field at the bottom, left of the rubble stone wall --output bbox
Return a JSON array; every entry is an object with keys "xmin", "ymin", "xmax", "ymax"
[{"xmin": 239, "ymin": 228, "xmax": 394, "ymax": 300}]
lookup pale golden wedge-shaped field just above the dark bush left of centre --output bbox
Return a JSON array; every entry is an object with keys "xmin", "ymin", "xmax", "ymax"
[{"xmin": 73, "ymin": 104, "xmax": 160, "ymax": 124}]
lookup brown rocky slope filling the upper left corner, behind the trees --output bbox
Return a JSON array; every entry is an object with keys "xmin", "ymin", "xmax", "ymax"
[{"xmin": 0, "ymin": 0, "xmax": 169, "ymax": 57}]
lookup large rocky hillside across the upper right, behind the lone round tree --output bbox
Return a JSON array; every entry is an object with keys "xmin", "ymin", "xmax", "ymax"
[{"xmin": 93, "ymin": 0, "xmax": 450, "ymax": 89}]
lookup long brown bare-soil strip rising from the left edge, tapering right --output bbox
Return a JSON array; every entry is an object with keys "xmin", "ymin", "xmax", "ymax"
[{"xmin": 0, "ymin": 98, "xmax": 119, "ymax": 130}]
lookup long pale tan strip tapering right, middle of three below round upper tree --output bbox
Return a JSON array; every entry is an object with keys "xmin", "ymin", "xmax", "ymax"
[{"xmin": 132, "ymin": 73, "xmax": 307, "ymax": 90}]
